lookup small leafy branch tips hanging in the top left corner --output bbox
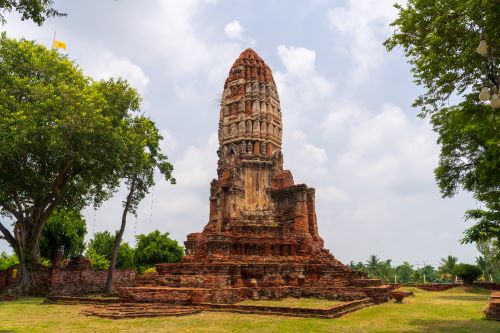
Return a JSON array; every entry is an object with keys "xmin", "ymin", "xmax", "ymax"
[{"xmin": 0, "ymin": 0, "xmax": 66, "ymax": 25}]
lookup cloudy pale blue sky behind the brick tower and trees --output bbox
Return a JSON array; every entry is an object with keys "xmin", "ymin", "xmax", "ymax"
[{"xmin": 0, "ymin": 0, "xmax": 478, "ymax": 267}]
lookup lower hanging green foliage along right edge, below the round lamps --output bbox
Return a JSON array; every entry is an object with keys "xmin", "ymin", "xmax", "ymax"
[{"xmin": 431, "ymin": 94, "xmax": 500, "ymax": 243}]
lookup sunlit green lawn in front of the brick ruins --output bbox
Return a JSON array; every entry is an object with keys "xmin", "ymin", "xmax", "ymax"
[{"xmin": 0, "ymin": 288, "xmax": 500, "ymax": 333}]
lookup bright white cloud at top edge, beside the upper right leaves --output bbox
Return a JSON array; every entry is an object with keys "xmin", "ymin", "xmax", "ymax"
[{"xmin": 327, "ymin": 0, "xmax": 396, "ymax": 85}]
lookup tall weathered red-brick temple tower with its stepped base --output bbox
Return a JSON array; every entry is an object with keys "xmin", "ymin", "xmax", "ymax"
[{"xmin": 119, "ymin": 49, "xmax": 390, "ymax": 304}]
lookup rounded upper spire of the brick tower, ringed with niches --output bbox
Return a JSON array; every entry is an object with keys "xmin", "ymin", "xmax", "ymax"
[{"xmin": 219, "ymin": 48, "xmax": 282, "ymax": 155}]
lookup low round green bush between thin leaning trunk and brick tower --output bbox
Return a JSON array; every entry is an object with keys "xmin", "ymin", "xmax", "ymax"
[{"xmin": 135, "ymin": 230, "xmax": 184, "ymax": 272}]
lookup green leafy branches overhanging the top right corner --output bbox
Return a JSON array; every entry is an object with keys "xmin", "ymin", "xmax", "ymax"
[{"xmin": 384, "ymin": 0, "xmax": 500, "ymax": 116}]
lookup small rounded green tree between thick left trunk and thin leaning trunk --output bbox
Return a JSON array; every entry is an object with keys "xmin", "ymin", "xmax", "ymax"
[{"xmin": 40, "ymin": 208, "xmax": 87, "ymax": 262}]
